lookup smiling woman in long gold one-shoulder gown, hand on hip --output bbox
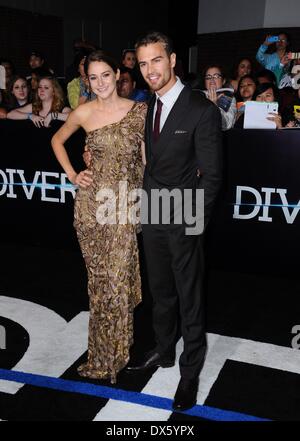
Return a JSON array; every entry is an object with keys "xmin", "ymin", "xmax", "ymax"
[{"xmin": 52, "ymin": 51, "xmax": 147, "ymax": 383}]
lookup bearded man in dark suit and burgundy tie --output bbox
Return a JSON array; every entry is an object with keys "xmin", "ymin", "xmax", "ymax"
[{"xmin": 127, "ymin": 32, "xmax": 222, "ymax": 410}]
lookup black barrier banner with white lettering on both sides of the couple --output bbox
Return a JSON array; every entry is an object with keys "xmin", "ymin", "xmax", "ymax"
[{"xmin": 0, "ymin": 121, "xmax": 300, "ymax": 277}]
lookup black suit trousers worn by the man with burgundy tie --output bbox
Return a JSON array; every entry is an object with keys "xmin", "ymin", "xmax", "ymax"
[{"xmin": 143, "ymin": 225, "xmax": 206, "ymax": 379}]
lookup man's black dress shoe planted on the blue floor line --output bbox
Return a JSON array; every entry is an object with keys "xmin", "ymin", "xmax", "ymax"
[{"xmin": 173, "ymin": 378, "xmax": 199, "ymax": 411}]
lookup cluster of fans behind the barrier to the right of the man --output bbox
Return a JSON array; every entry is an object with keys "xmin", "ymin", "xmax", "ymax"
[{"xmin": 191, "ymin": 32, "xmax": 300, "ymax": 130}]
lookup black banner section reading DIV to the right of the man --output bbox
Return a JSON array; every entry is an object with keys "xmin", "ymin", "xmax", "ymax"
[{"xmin": 207, "ymin": 129, "xmax": 300, "ymax": 277}]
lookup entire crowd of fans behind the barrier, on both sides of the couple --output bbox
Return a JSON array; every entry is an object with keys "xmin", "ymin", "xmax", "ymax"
[{"xmin": 0, "ymin": 32, "xmax": 300, "ymax": 130}]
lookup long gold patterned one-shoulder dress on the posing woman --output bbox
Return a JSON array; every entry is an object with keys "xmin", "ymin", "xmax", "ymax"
[{"xmin": 74, "ymin": 103, "xmax": 147, "ymax": 383}]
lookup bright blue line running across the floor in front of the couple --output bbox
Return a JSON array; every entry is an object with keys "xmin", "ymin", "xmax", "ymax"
[{"xmin": 0, "ymin": 369, "xmax": 270, "ymax": 421}]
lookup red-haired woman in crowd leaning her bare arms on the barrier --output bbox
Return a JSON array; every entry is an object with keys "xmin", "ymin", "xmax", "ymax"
[{"xmin": 7, "ymin": 77, "xmax": 71, "ymax": 128}]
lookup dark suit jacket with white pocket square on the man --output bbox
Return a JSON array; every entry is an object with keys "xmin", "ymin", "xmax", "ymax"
[{"xmin": 144, "ymin": 87, "xmax": 222, "ymax": 224}]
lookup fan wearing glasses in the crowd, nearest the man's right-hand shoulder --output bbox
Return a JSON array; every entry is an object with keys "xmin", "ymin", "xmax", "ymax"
[{"xmin": 204, "ymin": 65, "xmax": 237, "ymax": 130}]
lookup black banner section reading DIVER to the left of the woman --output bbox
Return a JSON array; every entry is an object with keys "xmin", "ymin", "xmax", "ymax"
[{"xmin": 0, "ymin": 121, "xmax": 85, "ymax": 248}]
